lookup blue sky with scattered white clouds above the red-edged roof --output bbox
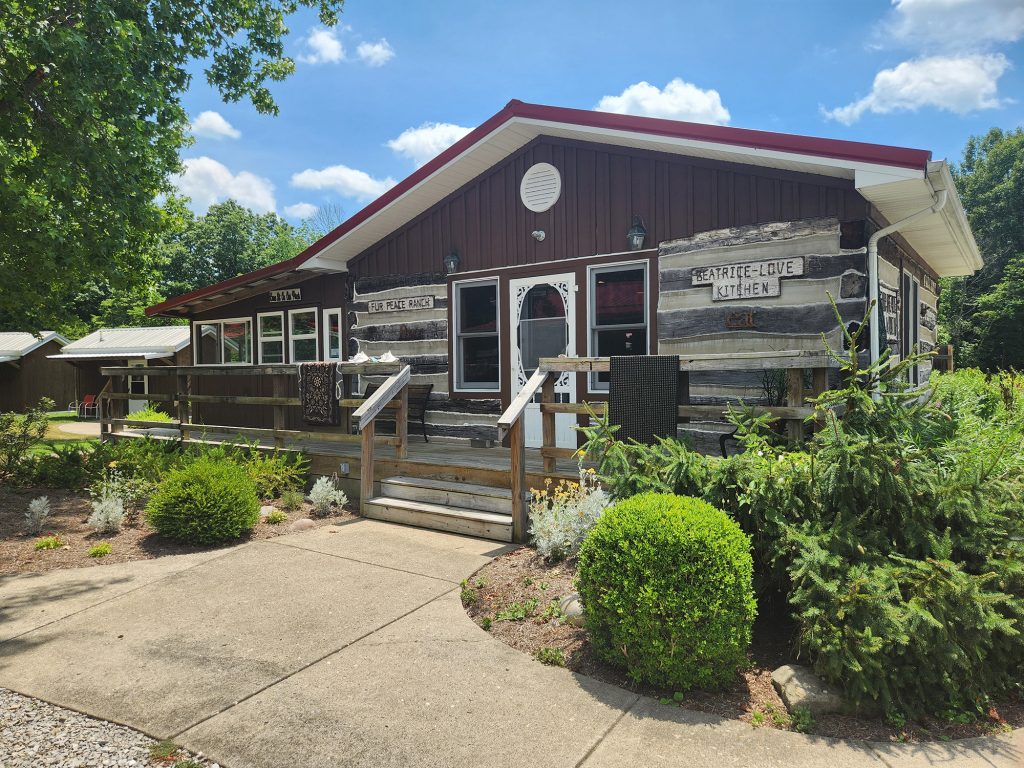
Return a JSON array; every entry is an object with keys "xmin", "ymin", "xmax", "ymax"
[{"xmin": 178, "ymin": 0, "xmax": 1024, "ymax": 222}]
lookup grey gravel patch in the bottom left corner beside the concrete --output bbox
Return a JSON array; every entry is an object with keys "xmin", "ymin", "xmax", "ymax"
[{"xmin": 0, "ymin": 688, "xmax": 221, "ymax": 768}]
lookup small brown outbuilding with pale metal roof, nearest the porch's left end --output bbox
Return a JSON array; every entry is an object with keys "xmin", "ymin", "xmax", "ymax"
[{"xmin": 50, "ymin": 326, "xmax": 191, "ymax": 414}]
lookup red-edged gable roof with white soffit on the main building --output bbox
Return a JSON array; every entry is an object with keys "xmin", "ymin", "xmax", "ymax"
[{"xmin": 146, "ymin": 100, "xmax": 982, "ymax": 314}]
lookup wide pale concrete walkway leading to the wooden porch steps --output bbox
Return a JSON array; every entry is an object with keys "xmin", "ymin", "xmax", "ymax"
[{"xmin": 0, "ymin": 520, "xmax": 1024, "ymax": 768}]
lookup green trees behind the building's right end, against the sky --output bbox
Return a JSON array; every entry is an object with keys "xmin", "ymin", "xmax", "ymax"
[{"xmin": 939, "ymin": 128, "xmax": 1024, "ymax": 371}]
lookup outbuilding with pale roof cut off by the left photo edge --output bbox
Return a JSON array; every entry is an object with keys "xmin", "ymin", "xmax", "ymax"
[{"xmin": 0, "ymin": 331, "xmax": 76, "ymax": 411}]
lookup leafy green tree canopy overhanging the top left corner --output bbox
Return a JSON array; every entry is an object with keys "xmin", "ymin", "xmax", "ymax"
[{"xmin": 0, "ymin": 0, "xmax": 343, "ymax": 330}]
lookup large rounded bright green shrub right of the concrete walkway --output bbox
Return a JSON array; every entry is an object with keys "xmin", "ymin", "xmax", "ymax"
[{"xmin": 577, "ymin": 494, "xmax": 756, "ymax": 690}]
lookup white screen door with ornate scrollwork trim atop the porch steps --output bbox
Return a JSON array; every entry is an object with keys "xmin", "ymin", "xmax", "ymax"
[{"xmin": 509, "ymin": 273, "xmax": 577, "ymax": 447}]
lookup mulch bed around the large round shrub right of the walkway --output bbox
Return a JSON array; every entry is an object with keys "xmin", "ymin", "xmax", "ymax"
[{"xmin": 463, "ymin": 548, "xmax": 1024, "ymax": 741}]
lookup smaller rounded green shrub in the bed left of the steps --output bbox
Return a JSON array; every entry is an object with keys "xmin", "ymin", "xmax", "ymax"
[{"xmin": 145, "ymin": 459, "xmax": 259, "ymax": 544}]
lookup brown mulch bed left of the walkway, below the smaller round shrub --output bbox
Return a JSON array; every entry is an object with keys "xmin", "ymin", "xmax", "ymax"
[{"xmin": 0, "ymin": 487, "xmax": 351, "ymax": 573}]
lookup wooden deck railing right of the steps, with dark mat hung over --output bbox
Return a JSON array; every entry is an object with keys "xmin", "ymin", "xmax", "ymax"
[{"xmin": 498, "ymin": 351, "xmax": 836, "ymax": 543}]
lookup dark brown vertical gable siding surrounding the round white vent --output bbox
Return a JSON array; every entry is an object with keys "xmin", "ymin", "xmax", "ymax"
[{"xmin": 349, "ymin": 137, "xmax": 867, "ymax": 278}]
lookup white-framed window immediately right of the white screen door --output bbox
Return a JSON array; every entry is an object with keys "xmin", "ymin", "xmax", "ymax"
[{"xmin": 587, "ymin": 261, "xmax": 650, "ymax": 392}]
